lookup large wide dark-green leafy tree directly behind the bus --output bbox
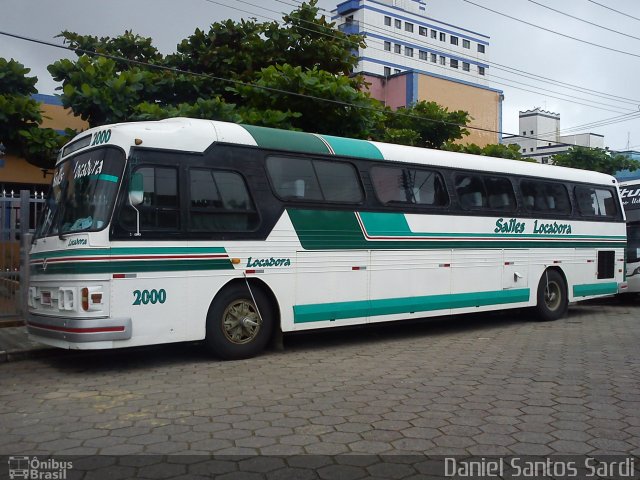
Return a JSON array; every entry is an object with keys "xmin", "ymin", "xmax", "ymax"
[{"xmin": 43, "ymin": 0, "xmax": 468, "ymax": 148}]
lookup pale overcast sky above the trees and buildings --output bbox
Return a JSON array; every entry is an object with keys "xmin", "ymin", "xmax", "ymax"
[{"xmin": 0, "ymin": 0, "xmax": 640, "ymax": 150}]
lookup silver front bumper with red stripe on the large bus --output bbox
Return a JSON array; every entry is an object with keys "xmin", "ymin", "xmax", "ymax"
[{"xmin": 27, "ymin": 314, "xmax": 131, "ymax": 343}]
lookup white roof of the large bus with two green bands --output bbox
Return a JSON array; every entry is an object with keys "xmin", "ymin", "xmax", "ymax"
[{"xmin": 67, "ymin": 117, "xmax": 617, "ymax": 185}]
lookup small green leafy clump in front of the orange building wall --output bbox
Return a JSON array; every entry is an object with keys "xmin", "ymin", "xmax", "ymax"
[{"xmin": 378, "ymin": 101, "xmax": 469, "ymax": 148}]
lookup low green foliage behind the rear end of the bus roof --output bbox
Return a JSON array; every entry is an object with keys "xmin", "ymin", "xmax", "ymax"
[{"xmin": 552, "ymin": 147, "xmax": 640, "ymax": 175}]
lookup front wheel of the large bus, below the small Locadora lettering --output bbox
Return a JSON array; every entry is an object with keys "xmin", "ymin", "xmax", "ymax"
[{"xmin": 205, "ymin": 284, "xmax": 273, "ymax": 360}]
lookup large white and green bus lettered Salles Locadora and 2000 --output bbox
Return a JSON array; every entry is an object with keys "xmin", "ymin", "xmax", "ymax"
[{"xmin": 27, "ymin": 118, "xmax": 626, "ymax": 359}]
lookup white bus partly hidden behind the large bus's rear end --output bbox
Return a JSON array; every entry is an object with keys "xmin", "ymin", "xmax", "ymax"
[{"xmin": 620, "ymin": 179, "xmax": 640, "ymax": 293}]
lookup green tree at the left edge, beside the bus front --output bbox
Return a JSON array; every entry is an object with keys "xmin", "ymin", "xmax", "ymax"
[{"xmin": 0, "ymin": 58, "xmax": 70, "ymax": 168}]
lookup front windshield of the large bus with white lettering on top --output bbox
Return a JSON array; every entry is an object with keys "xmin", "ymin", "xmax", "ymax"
[{"xmin": 36, "ymin": 147, "xmax": 124, "ymax": 238}]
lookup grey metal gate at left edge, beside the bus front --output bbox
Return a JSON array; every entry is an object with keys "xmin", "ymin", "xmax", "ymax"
[{"xmin": 0, "ymin": 190, "xmax": 44, "ymax": 318}]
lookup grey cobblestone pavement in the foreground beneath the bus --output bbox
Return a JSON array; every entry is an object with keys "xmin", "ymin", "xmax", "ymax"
[{"xmin": 0, "ymin": 301, "xmax": 640, "ymax": 478}]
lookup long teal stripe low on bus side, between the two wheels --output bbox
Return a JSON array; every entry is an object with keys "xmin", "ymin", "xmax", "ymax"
[{"xmin": 293, "ymin": 288, "xmax": 531, "ymax": 323}]
